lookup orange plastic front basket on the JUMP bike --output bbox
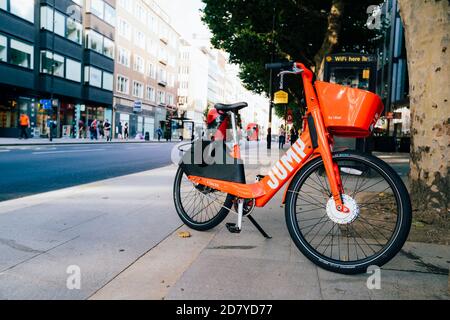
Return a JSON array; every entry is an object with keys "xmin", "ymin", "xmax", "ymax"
[{"xmin": 314, "ymin": 81, "xmax": 384, "ymax": 138}]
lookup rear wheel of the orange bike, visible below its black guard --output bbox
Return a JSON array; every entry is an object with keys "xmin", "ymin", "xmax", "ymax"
[{"xmin": 173, "ymin": 167, "xmax": 234, "ymax": 231}]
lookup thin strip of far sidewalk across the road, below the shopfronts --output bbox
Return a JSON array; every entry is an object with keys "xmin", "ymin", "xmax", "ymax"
[{"xmin": 0, "ymin": 138, "xmax": 177, "ymax": 147}]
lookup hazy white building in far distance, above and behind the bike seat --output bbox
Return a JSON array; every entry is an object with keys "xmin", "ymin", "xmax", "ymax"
[{"xmin": 178, "ymin": 39, "xmax": 281, "ymax": 140}]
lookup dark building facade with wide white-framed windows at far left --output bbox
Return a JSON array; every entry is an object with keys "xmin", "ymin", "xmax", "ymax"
[{"xmin": 0, "ymin": 0, "xmax": 116, "ymax": 137}]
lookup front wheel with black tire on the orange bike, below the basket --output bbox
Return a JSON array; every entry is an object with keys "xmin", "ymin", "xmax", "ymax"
[{"xmin": 285, "ymin": 152, "xmax": 412, "ymax": 274}]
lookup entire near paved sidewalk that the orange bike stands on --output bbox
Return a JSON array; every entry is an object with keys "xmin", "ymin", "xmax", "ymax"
[{"xmin": 0, "ymin": 145, "xmax": 450, "ymax": 300}]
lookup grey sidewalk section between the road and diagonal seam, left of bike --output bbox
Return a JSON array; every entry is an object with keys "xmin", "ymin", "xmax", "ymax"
[{"xmin": 0, "ymin": 166, "xmax": 181, "ymax": 299}]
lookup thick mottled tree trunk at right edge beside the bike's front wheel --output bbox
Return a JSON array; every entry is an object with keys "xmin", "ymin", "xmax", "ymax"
[{"xmin": 398, "ymin": 0, "xmax": 450, "ymax": 224}]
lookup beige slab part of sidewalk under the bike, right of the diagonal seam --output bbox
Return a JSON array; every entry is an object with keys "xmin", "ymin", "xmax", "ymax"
[{"xmin": 91, "ymin": 149, "xmax": 450, "ymax": 300}]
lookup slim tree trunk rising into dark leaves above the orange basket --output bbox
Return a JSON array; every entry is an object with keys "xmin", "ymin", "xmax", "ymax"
[{"xmin": 314, "ymin": 0, "xmax": 344, "ymax": 79}]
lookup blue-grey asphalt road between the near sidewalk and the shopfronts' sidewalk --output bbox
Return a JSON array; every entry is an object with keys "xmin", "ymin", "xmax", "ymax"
[{"xmin": 0, "ymin": 143, "xmax": 174, "ymax": 201}]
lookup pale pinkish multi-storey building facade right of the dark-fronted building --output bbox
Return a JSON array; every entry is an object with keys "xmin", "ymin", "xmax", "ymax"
[{"xmin": 114, "ymin": 0, "xmax": 180, "ymax": 139}]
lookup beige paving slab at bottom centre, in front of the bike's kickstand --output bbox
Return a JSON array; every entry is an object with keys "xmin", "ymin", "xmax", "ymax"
[{"xmin": 167, "ymin": 252, "xmax": 321, "ymax": 300}]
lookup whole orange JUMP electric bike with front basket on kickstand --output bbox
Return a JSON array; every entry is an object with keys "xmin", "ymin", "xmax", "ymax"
[{"xmin": 173, "ymin": 63, "xmax": 411, "ymax": 274}]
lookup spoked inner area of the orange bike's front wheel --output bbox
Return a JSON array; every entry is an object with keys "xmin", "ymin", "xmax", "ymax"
[{"xmin": 289, "ymin": 158, "xmax": 406, "ymax": 263}]
